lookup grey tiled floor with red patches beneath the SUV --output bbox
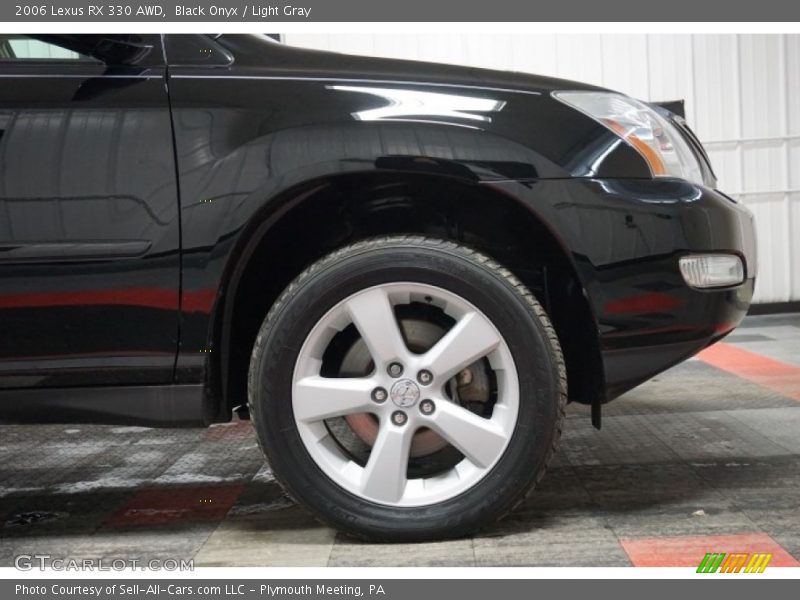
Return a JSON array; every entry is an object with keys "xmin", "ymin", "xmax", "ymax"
[{"xmin": 0, "ymin": 315, "xmax": 800, "ymax": 566}]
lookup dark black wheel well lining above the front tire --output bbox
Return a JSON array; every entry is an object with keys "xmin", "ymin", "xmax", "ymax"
[{"xmin": 208, "ymin": 172, "xmax": 605, "ymax": 420}]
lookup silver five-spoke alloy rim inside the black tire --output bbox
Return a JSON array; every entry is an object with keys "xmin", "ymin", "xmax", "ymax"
[{"xmin": 292, "ymin": 282, "xmax": 519, "ymax": 506}]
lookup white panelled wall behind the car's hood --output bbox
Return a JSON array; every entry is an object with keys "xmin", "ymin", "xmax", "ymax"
[{"xmin": 284, "ymin": 34, "xmax": 800, "ymax": 302}]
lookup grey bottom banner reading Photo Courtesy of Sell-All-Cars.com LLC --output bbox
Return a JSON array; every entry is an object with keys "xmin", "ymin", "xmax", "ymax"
[{"xmin": 0, "ymin": 574, "xmax": 797, "ymax": 600}]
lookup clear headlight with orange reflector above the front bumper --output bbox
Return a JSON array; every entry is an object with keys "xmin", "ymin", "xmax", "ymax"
[{"xmin": 553, "ymin": 92, "xmax": 703, "ymax": 184}]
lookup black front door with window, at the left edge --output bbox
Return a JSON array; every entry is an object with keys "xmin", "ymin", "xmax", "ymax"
[{"xmin": 0, "ymin": 35, "xmax": 180, "ymax": 388}]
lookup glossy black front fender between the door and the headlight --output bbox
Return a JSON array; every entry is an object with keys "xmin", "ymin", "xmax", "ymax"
[{"xmin": 169, "ymin": 68, "xmax": 649, "ymax": 396}]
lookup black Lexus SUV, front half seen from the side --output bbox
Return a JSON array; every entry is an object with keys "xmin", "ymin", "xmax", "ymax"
[{"xmin": 0, "ymin": 35, "xmax": 756, "ymax": 540}]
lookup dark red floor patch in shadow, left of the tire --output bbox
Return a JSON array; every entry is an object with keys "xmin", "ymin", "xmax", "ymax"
[{"xmin": 106, "ymin": 485, "xmax": 244, "ymax": 526}]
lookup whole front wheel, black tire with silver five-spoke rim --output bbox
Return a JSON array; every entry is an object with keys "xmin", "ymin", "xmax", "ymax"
[{"xmin": 248, "ymin": 236, "xmax": 567, "ymax": 542}]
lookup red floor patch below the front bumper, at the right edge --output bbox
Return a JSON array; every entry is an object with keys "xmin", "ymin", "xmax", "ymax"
[{"xmin": 697, "ymin": 343, "xmax": 800, "ymax": 400}]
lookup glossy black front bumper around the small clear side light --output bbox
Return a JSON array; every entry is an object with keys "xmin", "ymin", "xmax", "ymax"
[{"xmin": 488, "ymin": 178, "xmax": 757, "ymax": 401}]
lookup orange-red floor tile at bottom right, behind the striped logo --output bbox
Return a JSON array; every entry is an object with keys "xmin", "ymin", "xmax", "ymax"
[{"xmin": 620, "ymin": 533, "xmax": 800, "ymax": 568}]
